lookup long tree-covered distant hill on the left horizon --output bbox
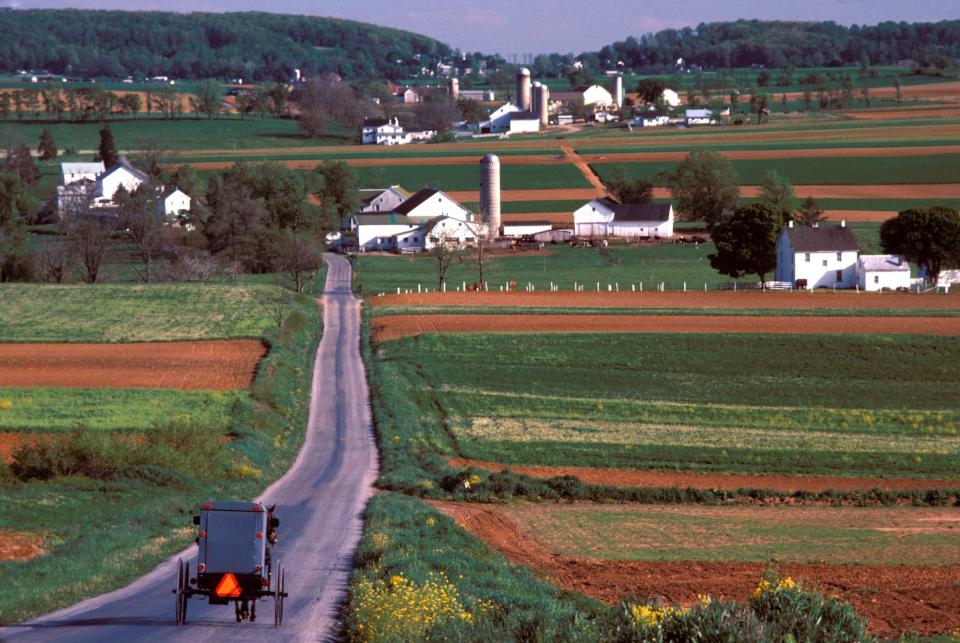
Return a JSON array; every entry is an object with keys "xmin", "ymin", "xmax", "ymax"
[{"xmin": 0, "ymin": 5, "xmax": 452, "ymax": 80}]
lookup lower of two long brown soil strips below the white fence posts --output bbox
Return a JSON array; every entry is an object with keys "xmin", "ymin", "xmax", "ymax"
[{"xmin": 371, "ymin": 315, "xmax": 960, "ymax": 342}]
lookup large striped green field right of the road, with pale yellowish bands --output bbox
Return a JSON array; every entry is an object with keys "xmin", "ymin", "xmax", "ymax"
[{"xmin": 377, "ymin": 334, "xmax": 960, "ymax": 478}]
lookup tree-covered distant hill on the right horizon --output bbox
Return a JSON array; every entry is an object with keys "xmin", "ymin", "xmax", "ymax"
[{"xmin": 585, "ymin": 20, "xmax": 960, "ymax": 69}]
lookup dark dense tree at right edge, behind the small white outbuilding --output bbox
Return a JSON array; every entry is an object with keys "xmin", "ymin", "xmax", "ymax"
[{"xmin": 880, "ymin": 206, "xmax": 960, "ymax": 282}]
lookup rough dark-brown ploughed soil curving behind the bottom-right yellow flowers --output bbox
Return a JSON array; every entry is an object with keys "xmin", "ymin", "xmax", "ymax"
[{"xmin": 431, "ymin": 501, "xmax": 960, "ymax": 637}]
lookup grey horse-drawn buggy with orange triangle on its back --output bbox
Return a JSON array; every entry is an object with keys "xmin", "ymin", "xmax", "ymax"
[{"xmin": 174, "ymin": 502, "xmax": 287, "ymax": 627}]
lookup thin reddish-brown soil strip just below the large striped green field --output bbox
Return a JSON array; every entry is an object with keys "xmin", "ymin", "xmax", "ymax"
[{"xmin": 447, "ymin": 458, "xmax": 960, "ymax": 493}]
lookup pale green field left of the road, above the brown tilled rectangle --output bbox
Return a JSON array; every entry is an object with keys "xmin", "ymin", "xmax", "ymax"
[{"xmin": 0, "ymin": 283, "xmax": 273, "ymax": 342}]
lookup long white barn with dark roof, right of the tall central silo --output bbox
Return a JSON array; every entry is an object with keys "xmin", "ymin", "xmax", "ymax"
[{"xmin": 573, "ymin": 197, "xmax": 673, "ymax": 239}]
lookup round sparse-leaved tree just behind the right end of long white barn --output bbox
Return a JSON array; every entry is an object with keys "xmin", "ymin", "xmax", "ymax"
[{"xmin": 667, "ymin": 151, "xmax": 740, "ymax": 229}]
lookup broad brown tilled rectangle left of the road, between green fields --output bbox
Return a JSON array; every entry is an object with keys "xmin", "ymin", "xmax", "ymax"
[{"xmin": 0, "ymin": 339, "xmax": 267, "ymax": 391}]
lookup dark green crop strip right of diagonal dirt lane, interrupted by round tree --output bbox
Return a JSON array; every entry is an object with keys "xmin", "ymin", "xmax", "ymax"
[{"xmin": 591, "ymin": 154, "xmax": 960, "ymax": 186}]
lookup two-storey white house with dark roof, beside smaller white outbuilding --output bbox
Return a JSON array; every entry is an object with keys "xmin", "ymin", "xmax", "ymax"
[{"xmin": 775, "ymin": 221, "xmax": 859, "ymax": 289}]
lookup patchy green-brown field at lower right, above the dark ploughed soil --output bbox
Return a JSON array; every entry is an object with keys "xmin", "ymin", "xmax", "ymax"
[{"xmin": 507, "ymin": 505, "xmax": 960, "ymax": 566}]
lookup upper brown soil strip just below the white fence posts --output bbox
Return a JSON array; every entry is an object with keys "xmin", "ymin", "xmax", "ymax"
[{"xmin": 369, "ymin": 291, "xmax": 960, "ymax": 310}]
